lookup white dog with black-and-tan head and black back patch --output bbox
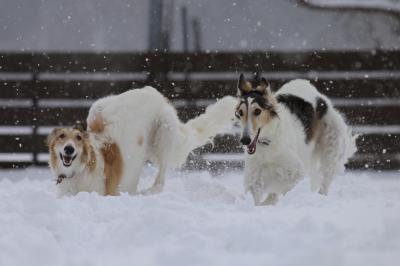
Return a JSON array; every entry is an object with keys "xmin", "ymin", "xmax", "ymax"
[{"xmin": 235, "ymin": 75, "xmax": 357, "ymax": 205}]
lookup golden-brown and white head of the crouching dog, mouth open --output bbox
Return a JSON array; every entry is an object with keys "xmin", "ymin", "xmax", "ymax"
[{"xmin": 47, "ymin": 128, "xmax": 89, "ymax": 174}]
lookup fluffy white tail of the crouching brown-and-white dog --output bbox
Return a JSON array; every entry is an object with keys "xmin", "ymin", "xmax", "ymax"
[{"xmin": 171, "ymin": 96, "xmax": 236, "ymax": 166}]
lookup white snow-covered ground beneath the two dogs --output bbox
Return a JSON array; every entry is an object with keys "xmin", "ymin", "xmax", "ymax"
[{"xmin": 0, "ymin": 169, "xmax": 400, "ymax": 266}]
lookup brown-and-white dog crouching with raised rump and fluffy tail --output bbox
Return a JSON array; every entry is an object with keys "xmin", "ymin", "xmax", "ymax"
[{"xmin": 48, "ymin": 87, "xmax": 236, "ymax": 196}]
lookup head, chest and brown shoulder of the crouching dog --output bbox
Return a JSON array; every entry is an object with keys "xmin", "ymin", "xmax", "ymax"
[{"xmin": 47, "ymin": 125, "xmax": 123, "ymax": 196}]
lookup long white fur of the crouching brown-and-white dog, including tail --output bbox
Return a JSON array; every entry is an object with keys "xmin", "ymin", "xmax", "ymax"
[{"xmin": 59, "ymin": 87, "xmax": 236, "ymax": 194}]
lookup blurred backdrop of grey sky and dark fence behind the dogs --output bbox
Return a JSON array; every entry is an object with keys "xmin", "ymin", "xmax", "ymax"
[{"xmin": 0, "ymin": 0, "xmax": 400, "ymax": 172}]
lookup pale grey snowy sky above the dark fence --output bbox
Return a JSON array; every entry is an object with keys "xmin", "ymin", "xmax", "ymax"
[{"xmin": 0, "ymin": 0, "xmax": 400, "ymax": 51}]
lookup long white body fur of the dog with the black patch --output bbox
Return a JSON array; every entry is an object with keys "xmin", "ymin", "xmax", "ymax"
[{"xmin": 245, "ymin": 80, "xmax": 357, "ymax": 205}]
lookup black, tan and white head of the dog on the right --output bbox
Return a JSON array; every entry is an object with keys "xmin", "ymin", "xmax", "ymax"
[{"xmin": 235, "ymin": 74, "xmax": 277, "ymax": 154}]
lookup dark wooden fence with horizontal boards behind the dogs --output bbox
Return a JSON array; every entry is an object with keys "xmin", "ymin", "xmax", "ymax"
[{"xmin": 0, "ymin": 51, "xmax": 400, "ymax": 170}]
